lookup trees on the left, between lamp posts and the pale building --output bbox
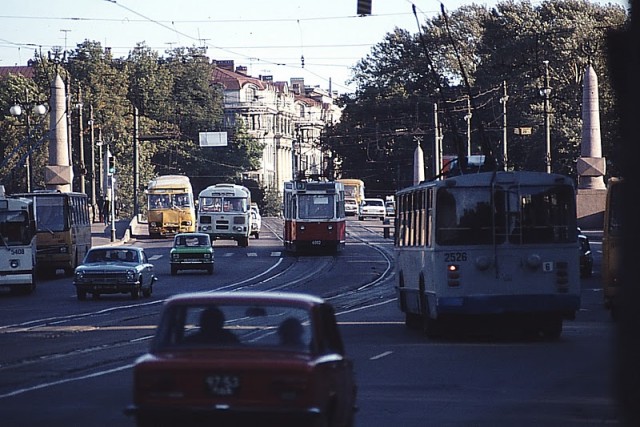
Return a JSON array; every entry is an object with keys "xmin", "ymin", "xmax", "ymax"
[{"xmin": 0, "ymin": 41, "xmax": 263, "ymax": 216}]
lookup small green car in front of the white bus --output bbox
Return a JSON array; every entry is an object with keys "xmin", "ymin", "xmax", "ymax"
[{"xmin": 169, "ymin": 233, "xmax": 214, "ymax": 276}]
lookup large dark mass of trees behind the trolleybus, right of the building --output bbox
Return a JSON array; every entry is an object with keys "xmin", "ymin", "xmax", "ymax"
[{"xmin": 323, "ymin": 0, "xmax": 628, "ymax": 194}]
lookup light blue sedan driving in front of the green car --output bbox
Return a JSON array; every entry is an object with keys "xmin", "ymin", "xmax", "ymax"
[{"xmin": 73, "ymin": 245, "xmax": 157, "ymax": 301}]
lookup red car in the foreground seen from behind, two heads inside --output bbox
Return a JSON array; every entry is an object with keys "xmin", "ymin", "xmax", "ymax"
[{"xmin": 125, "ymin": 292, "xmax": 357, "ymax": 426}]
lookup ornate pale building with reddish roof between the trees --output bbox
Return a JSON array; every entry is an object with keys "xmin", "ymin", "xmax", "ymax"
[{"xmin": 212, "ymin": 61, "xmax": 340, "ymax": 191}]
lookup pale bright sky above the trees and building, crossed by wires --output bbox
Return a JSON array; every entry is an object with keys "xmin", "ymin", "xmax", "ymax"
[{"xmin": 0, "ymin": 0, "xmax": 628, "ymax": 93}]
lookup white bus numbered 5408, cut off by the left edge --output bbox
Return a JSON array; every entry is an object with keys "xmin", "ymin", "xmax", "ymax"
[{"xmin": 0, "ymin": 185, "xmax": 37, "ymax": 294}]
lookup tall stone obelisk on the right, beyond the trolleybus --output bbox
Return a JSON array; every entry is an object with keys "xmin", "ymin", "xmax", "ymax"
[{"xmin": 576, "ymin": 64, "xmax": 607, "ymax": 229}]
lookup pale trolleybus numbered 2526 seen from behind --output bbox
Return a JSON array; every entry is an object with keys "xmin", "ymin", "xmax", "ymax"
[{"xmin": 394, "ymin": 171, "xmax": 581, "ymax": 340}]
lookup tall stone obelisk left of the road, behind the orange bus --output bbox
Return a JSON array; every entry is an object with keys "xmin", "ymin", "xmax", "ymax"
[{"xmin": 45, "ymin": 74, "xmax": 73, "ymax": 192}]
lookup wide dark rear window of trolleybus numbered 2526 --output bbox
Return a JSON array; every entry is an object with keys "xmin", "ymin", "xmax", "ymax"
[{"xmin": 436, "ymin": 186, "xmax": 577, "ymax": 245}]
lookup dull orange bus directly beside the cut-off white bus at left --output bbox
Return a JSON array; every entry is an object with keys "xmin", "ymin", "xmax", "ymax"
[{"xmin": 14, "ymin": 190, "xmax": 91, "ymax": 276}]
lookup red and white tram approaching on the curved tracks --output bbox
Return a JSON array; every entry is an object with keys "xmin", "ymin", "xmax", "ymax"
[{"xmin": 283, "ymin": 180, "xmax": 346, "ymax": 253}]
